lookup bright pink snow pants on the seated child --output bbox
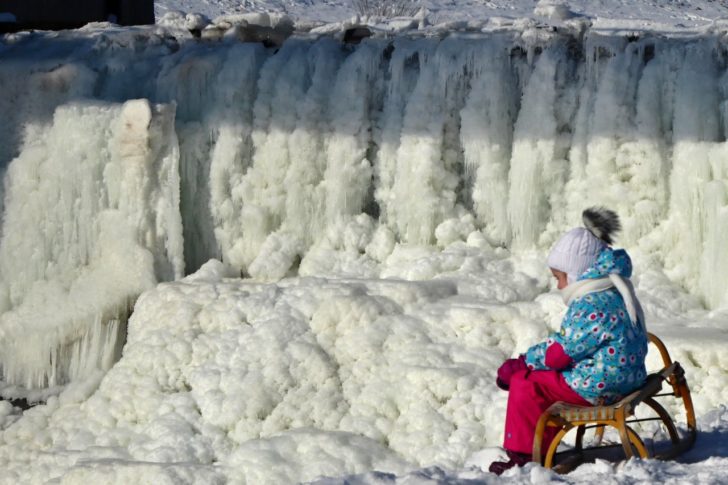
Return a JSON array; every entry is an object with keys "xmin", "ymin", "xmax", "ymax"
[{"xmin": 503, "ymin": 370, "xmax": 590, "ymax": 455}]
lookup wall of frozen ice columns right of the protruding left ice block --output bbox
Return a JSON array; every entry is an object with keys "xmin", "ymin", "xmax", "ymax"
[{"xmin": 152, "ymin": 31, "xmax": 728, "ymax": 307}]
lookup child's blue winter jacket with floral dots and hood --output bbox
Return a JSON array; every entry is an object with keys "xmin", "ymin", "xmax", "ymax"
[{"xmin": 526, "ymin": 248, "xmax": 647, "ymax": 405}]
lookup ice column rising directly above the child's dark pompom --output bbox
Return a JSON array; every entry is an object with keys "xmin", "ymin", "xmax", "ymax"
[{"xmin": 566, "ymin": 43, "xmax": 667, "ymax": 246}]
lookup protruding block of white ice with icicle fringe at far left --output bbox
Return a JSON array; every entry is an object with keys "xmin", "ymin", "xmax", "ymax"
[{"xmin": 0, "ymin": 100, "xmax": 184, "ymax": 388}]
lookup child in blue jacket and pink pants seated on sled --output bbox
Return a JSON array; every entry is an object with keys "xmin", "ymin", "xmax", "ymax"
[{"xmin": 489, "ymin": 208, "xmax": 647, "ymax": 475}]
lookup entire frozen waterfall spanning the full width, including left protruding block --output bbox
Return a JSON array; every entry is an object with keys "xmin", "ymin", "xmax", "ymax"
[{"xmin": 0, "ymin": 25, "xmax": 728, "ymax": 387}]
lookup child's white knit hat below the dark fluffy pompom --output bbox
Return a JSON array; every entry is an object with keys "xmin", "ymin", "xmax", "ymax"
[{"xmin": 547, "ymin": 227, "xmax": 607, "ymax": 284}]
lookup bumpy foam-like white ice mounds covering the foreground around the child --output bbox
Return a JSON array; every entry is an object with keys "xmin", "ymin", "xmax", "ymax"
[{"xmin": 0, "ymin": 246, "xmax": 728, "ymax": 483}]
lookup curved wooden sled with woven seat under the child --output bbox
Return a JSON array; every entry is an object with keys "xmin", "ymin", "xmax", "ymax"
[{"xmin": 533, "ymin": 333, "xmax": 697, "ymax": 473}]
